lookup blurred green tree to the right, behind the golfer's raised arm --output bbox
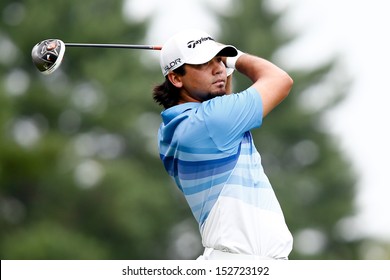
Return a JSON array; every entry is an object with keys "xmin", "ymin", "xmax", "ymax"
[{"xmin": 216, "ymin": 1, "xmax": 372, "ymax": 259}]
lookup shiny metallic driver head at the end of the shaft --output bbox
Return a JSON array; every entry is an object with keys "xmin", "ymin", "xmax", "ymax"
[{"xmin": 31, "ymin": 39, "xmax": 65, "ymax": 75}]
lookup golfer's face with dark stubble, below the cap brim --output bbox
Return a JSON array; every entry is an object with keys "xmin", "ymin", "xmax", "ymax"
[{"xmin": 181, "ymin": 56, "xmax": 227, "ymax": 102}]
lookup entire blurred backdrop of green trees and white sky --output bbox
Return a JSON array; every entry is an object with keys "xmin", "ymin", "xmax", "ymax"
[{"xmin": 0, "ymin": 0, "xmax": 390, "ymax": 260}]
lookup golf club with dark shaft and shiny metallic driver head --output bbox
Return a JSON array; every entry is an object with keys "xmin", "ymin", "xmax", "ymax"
[{"xmin": 31, "ymin": 39, "xmax": 161, "ymax": 75}]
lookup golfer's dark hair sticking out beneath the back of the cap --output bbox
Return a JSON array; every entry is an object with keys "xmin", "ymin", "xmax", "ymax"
[{"xmin": 153, "ymin": 65, "xmax": 186, "ymax": 109}]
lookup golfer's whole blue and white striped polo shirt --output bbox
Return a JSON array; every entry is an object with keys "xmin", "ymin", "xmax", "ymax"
[{"xmin": 159, "ymin": 87, "xmax": 292, "ymax": 259}]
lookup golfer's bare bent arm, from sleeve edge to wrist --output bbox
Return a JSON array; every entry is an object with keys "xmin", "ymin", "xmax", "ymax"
[{"xmin": 229, "ymin": 54, "xmax": 293, "ymax": 117}]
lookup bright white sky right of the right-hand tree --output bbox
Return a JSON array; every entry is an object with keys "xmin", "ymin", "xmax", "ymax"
[{"xmin": 272, "ymin": 0, "xmax": 390, "ymax": 240}]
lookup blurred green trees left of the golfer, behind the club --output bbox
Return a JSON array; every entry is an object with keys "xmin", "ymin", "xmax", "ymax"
[{"xmin": 0, "ymin": 0, "xmax": 188, "ymax": 259}]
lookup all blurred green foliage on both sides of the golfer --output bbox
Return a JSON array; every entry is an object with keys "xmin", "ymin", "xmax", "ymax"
[{"xmin": 0, "ymin": 0, "xmax": 389, "ymax": 259}]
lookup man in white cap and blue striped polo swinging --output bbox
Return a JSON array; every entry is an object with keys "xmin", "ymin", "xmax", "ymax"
[{"xmin": 153, "ymin": 29, "xmax": 293, "ymax": 260}]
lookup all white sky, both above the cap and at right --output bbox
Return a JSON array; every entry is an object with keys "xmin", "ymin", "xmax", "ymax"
[{"xmin": 126, "ymin": 0, "xmax": 390, "ymax": 240}]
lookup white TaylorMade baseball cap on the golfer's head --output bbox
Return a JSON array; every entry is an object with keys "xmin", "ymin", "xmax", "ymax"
[{"xmin": 160, "ymin": 29, "xmax": 237, "ymax": 76}]
